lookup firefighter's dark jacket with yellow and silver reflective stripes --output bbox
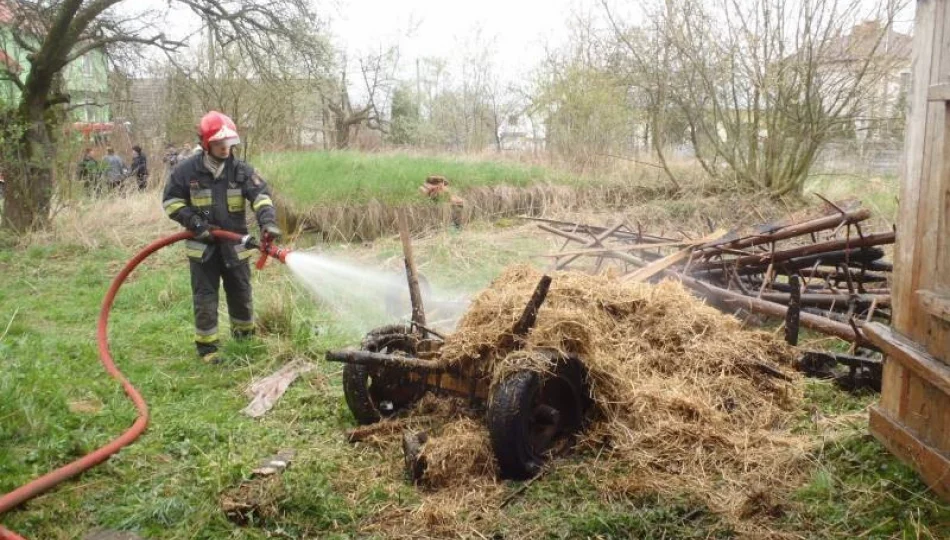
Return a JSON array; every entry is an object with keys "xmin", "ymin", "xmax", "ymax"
[{"xmin": 162, "ymin": 152, "xmax": 277, "ymax": 268}]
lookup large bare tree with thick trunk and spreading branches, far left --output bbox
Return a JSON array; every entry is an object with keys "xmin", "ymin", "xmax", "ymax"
[{"xmin": 0, "ymin": 0, "xmax": 314, "ymax": 231}]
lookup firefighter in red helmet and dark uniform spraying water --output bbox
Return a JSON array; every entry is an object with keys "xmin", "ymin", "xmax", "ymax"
[{"xmin": 162, "ymin": 111, "xmax": 281, "ymax": 362}]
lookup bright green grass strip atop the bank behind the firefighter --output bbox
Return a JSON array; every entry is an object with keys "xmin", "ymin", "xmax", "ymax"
[{"xmin": 253, "ymin": 152, "xmax": 571, "ymax": 207}]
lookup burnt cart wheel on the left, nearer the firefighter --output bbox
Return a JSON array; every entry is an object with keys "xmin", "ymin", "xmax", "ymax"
[{"xmin": 343, "ymin": 326, "xmax": 425, "ymax": 425}]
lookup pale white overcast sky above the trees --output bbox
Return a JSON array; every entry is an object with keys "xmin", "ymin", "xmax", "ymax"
[{"xmin": 145, "ymin": 0, "xmax": 915, "ymax": 89}]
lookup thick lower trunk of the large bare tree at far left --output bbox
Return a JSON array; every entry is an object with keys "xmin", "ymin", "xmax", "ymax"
[{"xmin": 3, "ymin": 103, "xmax": 56, "ymax": 232}]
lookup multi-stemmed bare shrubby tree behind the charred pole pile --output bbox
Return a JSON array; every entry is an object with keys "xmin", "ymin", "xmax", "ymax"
[{"xmin": 602, "ymin": 0, "xmax": 902, "ymax": 196}]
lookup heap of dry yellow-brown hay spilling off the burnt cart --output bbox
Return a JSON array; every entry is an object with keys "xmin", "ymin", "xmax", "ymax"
[{"xmin": 429, "ymin": 266, "xmax": 810, "ymax": 520}]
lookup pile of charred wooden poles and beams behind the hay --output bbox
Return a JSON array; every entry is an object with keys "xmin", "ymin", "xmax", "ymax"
[{"xmin": 525, "ymin": 201, "xmax": 895, "ymax": 348}]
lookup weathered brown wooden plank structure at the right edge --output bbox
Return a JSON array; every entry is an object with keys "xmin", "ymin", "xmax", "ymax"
[{"xmin": 871, "ymin": 0, "xmax": 950, "ymax": 497}]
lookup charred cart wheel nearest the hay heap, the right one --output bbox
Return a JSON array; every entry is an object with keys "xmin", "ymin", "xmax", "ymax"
[{"xmin": 488, "ymin": 358, "xmax": 591, "ymax": 480}]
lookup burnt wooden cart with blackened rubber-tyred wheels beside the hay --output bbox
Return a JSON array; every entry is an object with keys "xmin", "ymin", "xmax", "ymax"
[{"xmin": 327, "ymin": 276, "xmax": 591, "ymax": 479}]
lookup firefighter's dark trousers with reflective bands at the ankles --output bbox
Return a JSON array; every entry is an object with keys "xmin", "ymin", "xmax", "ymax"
[{"xmin": 190, "ymin": 250, "xmax": 254, "ymax": 356}]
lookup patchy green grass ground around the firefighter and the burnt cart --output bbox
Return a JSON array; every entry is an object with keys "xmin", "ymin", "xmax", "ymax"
[{"xmin": 0, "ymin": 182, "xmax": 950, "ymax": 539}]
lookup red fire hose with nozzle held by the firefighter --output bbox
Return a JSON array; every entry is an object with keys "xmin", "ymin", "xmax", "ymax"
[{"xmin": 0, "ymin": 230, "xmax": 289, "ymax": 540}]
